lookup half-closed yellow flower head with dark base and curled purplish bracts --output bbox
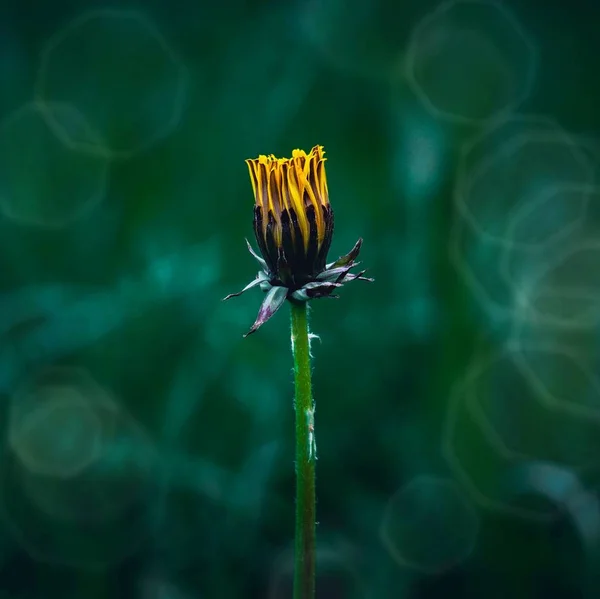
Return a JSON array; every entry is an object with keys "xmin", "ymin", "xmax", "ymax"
[{"xmin": 225, "ymin": 146, "xmax": 372, "ymax": 335}]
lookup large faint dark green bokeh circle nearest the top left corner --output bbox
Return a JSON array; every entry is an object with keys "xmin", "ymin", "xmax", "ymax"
[{"xmin": 36, "ymin": 9, "xmax": 187, "ymax": 158}]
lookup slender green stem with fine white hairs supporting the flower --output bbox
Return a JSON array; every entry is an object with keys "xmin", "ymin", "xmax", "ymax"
[{"xmin": 291, "ymin": 303, "xmax": 316, "ymax": 599}]
